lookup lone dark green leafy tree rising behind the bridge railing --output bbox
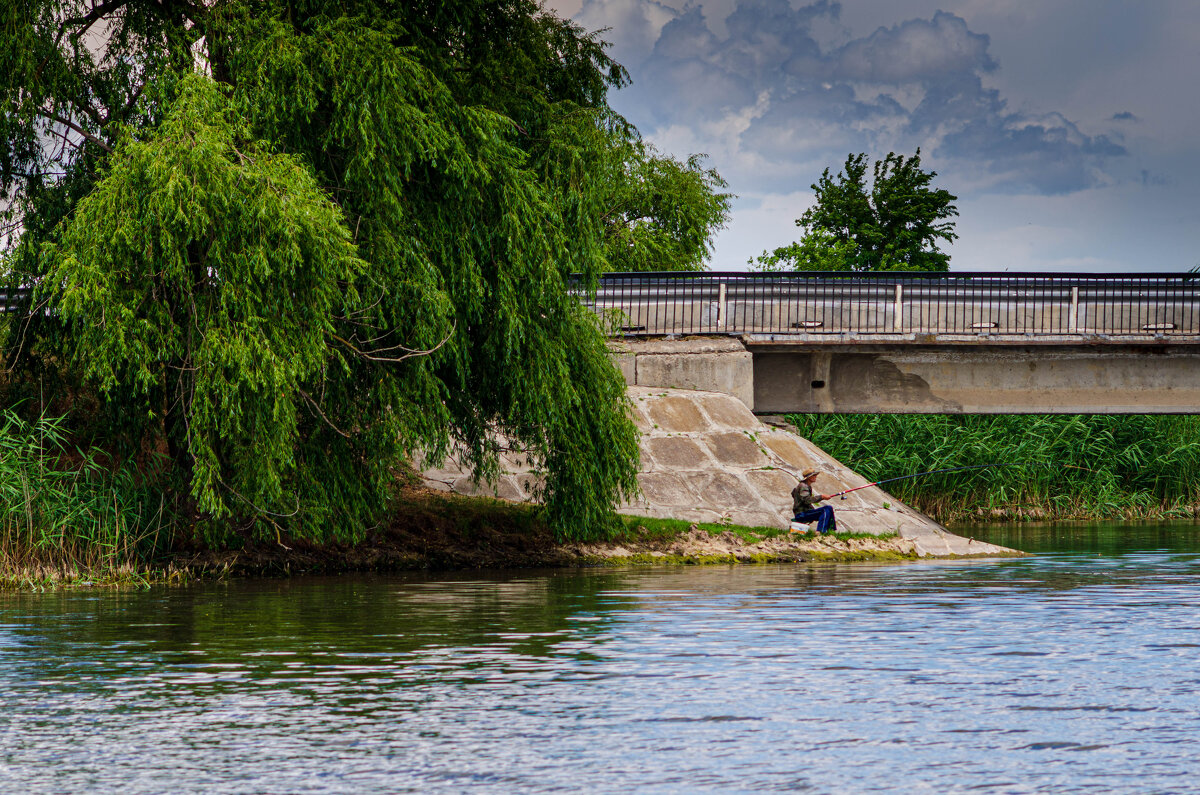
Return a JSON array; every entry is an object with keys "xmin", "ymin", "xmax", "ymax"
[{"xmin": 750, "ymin": 149, "xmax": 959, "ymax": 270}]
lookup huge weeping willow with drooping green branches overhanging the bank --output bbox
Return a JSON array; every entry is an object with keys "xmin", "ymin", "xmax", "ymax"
[{"xmin": 0, "ymin": 0, "xmax": 728, "ymax": 540}]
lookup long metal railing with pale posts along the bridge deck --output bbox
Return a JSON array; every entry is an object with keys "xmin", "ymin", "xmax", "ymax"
[{"xmin": 581, "ymin": 271, "xmax": 1200, "ymax": 341}]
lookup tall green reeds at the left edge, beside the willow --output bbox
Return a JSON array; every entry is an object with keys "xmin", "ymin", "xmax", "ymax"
[{"xmin": 0, "ymin": 411, "xmax": 167, "ymax": 586}]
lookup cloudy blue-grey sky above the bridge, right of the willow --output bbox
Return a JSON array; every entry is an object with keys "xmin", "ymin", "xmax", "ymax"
[{"xmin": 545, "ymin": 0, "xmax": 1200, "ymax": 273}]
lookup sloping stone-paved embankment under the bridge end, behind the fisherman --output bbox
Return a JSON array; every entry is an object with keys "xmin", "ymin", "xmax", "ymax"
[{"xmin": 424, "ymin": 387, "xmax": 1012, "ymax": 560}]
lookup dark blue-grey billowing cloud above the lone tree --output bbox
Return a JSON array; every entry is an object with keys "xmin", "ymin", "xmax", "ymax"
[{"xmin": 584, "ymin": 0, "xmax": 1132, "ymax": 195}]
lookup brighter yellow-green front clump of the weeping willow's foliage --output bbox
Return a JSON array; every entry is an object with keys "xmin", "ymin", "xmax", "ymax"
[{"xmin": 41, "ymin": 76, "xmax": 366, "ymax": 519}]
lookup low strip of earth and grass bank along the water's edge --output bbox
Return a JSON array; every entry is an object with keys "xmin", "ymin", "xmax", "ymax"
[{"xmin": 0, "ymin": 486, "xmax": 1012, "ymax": 590}]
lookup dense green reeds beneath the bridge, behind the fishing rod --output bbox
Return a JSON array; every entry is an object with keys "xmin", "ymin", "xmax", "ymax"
[{"xmin": 788, "ymin": 414, "xmax": 1200, "ymax": 522}]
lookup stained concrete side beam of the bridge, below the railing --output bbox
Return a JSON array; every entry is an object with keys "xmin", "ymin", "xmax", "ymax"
[{"xmin": 746, "ymin": 342, "xmax": 1200, "ymax": 414}]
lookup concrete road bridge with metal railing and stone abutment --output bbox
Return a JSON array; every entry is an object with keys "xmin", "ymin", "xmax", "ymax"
[{"xmin": 583, "ymin": 273, "xmax": 1200, "ymax": 413}]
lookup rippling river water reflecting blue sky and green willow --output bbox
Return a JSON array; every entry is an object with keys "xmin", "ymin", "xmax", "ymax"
[{"xmin": 0, "ymin": 525, "xmax": 1200, "ymax": 795}]
